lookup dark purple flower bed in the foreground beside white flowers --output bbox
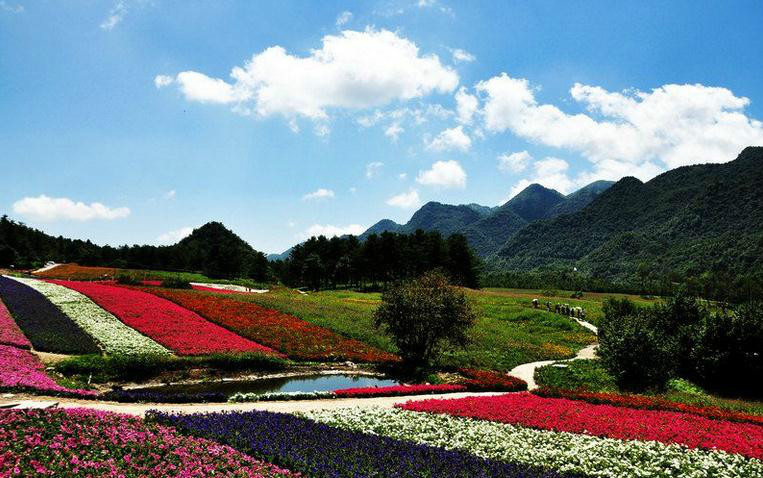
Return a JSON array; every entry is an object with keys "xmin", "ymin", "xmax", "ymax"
[{"xmin": 147, "ymin": 411, "xmax": 572, "ymax": 478}]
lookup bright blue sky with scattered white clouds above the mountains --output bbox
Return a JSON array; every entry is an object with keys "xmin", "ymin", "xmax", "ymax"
[{"xmin": 0, "ymin": 0, "xmax": 763, "ymax": 252}]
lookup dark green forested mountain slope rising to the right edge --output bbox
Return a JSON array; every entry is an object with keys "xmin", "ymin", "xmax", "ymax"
[{"xmin": 496, "ymin": 147, "xmax": 763, "ymax": 280}]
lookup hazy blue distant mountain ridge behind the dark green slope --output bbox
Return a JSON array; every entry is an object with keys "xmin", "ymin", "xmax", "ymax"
[{"xmin": 359, "ymin": 181, "xmax": 614, "ymax": 257}]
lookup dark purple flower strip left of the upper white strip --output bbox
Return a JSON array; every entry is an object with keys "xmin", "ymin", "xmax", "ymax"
[{"xmin": 0, "ymin": 276, "xmax": 100, "ymax": 354}]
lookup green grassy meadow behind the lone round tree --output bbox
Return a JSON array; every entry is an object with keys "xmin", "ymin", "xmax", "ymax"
[{"xmin": 224, "ymin": 288, "xmax": 603, "ymax": 371}]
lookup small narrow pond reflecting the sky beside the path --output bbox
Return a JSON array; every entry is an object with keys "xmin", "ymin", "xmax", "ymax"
[{"xmin": 134, "ymin": 374, "xmax": 399, "ymax": 396}]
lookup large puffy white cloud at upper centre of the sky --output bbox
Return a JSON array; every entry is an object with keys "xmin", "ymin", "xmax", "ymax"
[{"xmin": 160, "ymin": 28, "xmax": 458, "ymax": 125}]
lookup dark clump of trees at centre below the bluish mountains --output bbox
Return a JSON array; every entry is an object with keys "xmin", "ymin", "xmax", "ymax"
[{"xmin": 271, "ymin": 230, "xmax": 480, "ymax": 290}]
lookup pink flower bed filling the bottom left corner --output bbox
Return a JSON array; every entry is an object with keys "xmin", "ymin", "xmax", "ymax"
[{"xmin": 0, "ymin": 409, "xmax": 300, "ymax": 478}]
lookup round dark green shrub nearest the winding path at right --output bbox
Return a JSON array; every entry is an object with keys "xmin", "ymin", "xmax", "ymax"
[{"xmin": 598, "ymin": 299, "xmax": 677, "ymax": 391}]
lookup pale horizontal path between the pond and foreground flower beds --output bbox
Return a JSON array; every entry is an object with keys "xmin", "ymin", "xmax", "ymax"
[{"xmin": 0, "ymin": 392, "xmax": 504, "ymax": 416}]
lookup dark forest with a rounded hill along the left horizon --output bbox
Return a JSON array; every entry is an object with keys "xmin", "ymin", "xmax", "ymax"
[{"xmin": 0, "ymin": 216, "xmax": 269, "ymax": 281}]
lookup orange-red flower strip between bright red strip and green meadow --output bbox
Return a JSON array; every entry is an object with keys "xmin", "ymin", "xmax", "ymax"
[{"xmin": 130, "ymin": 287, "xmax": 398, "ymax": 362}]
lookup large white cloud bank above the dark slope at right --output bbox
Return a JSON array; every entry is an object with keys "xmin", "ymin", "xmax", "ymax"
[{"xmin": 476, "ymin": 73, "xmax": 763, "ymax": 180}]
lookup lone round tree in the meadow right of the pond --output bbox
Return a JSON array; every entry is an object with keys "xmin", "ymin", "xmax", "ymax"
[{"xmin": 374, "ymin": 272, "xmax": 476, "ymax": 366}]
